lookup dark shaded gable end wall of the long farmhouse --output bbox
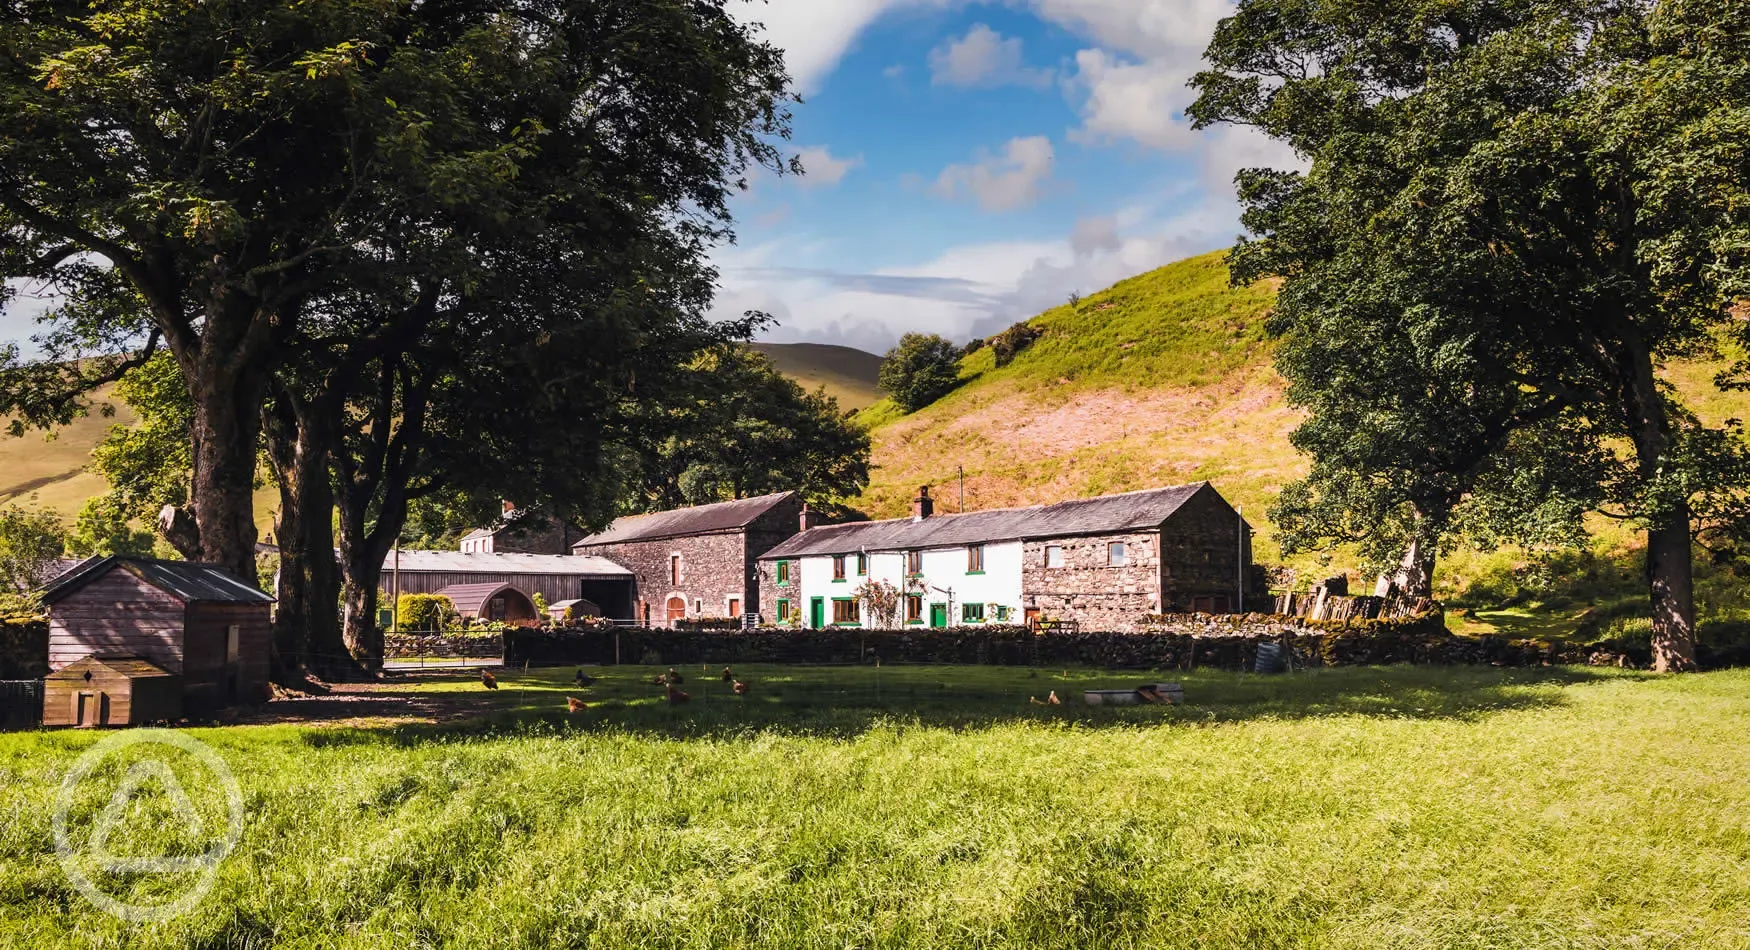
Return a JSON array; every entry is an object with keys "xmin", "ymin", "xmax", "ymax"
[{"xmin": 1160, "ymin": 488, "xmax": 1255, "ymax": 612}]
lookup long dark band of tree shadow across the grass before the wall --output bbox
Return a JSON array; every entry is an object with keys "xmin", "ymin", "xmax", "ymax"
[{"xmin": 276, "ymin": 667, "xmax": 1638, "ymax": 745}]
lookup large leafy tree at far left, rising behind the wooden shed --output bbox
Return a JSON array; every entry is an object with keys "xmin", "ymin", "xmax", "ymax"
[{"xmin": 0, "ymin": 0, "xmax": 786, "ymax": 576}]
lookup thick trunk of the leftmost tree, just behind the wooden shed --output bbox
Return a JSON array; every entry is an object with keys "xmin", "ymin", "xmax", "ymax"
[{"xmin": 191, "ymin": 371, "xmax": 266, "ymax": 583}]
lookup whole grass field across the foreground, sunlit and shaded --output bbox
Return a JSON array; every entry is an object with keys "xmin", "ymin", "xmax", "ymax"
[{"xmin": 0, "ymin": 667, "xmax": 1750, "ymax": 948}]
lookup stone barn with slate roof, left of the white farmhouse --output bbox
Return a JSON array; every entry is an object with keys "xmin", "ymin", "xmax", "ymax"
[{"xmin": 572, "ymin": 492, "xmax": 807, "ymax": 626}]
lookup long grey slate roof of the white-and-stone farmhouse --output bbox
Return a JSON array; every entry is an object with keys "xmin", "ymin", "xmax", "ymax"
[{"xmin": 760, "ymin": 481, "xmax": 1213, "ymax": 560}]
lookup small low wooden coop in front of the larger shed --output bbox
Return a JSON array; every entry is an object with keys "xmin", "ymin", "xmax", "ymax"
[{"xmin": 42, "ymin": 656, "xmax": 182, "ymax": 726}]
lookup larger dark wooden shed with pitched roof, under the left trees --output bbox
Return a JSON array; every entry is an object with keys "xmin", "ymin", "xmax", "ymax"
[{"xmin": 42, "ymin": 556, "xmax": 273, "ymax": 723}]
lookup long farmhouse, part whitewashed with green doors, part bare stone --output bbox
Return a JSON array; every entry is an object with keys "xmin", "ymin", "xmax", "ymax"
[{"xmin": 760, "ymin": 483, "xmax": 1251, "ymax": 632}]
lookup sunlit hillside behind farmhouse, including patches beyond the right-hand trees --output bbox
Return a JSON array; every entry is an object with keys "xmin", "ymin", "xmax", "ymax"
[{"xmin": 854, "ymin": 254, "xmax": 1750, "ymax": 635}]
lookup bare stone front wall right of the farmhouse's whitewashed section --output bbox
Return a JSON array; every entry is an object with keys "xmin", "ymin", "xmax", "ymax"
[{"xmin": 1020, "ymin": 532, "xmax": 1160, "ymax": 633}]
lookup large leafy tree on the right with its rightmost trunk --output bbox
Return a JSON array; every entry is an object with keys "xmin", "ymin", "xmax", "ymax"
[{"xmin": 1192, "ymin": 0, "xmax": 1731, "ymax": 670}]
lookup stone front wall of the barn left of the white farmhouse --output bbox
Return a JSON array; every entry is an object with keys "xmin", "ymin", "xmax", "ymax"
[{"xmin": 578, "ymin": 530, "xmax": 758, "ymax": 626}]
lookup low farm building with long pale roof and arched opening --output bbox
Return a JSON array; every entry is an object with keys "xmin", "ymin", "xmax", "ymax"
[{"xmin": 383, "ymin": 551, "xmax": 634, "ymax": 619}]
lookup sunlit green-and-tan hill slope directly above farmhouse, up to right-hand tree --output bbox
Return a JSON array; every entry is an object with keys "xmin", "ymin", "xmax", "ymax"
[{"xmin": 859, "ymin": 254, "xmax": 1304, "ymax": 556}]
